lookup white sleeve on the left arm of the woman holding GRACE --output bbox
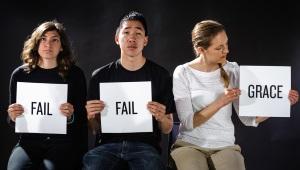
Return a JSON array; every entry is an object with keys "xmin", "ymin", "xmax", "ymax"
[{"xmin": 173, "ymin": 65, "xmax": 194, "ymax": 130}]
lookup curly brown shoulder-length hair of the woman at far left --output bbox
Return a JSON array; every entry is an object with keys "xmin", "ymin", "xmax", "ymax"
[{"xmin": 21, "ymin": 20, "xmax": 75, "ymax": 79}]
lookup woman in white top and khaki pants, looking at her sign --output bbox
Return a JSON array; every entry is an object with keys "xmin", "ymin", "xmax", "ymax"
[{"xmin": 171, "ymin": 20, "xmax": 299, "ymax": 170}]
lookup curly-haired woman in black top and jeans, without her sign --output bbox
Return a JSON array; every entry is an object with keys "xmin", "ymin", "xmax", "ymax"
[{"xmin": 7, "ymin": 21, "xmax": 87, "ymax": 170}]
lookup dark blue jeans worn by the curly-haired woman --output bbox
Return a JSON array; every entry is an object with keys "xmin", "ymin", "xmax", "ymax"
[{"xmin": 7, "ymin": 139, "xmax": 81, "ymax": 170}]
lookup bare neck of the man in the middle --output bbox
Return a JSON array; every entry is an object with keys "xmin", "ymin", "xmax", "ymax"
[{"xmin": 121, "ymin": 55, "xmax": 146, "ymax": 71}]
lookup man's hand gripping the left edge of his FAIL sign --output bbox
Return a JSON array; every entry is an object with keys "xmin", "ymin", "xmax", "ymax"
[{"xmin": 85, "ymin": 100, "xmax": 105, "ymax": 120}]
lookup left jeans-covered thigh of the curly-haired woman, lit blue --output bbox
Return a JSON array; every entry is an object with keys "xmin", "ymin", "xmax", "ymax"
[{"xmin": 7, "ymin": 146, "xmax": 33, "ymax": 170}]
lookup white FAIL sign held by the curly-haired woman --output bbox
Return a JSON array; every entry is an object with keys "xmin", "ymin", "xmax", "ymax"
[{"xmin": 15, "ymin": 82, "xmax": 68, "ymax": 134}]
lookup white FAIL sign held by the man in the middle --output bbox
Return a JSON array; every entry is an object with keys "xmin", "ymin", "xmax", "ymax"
[{"xmin": 100, "ymin": 81, "xmax": 153, "ymax": 133}]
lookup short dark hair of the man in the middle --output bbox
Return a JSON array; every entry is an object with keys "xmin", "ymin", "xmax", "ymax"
[{"xmin": 116, "ymin": 11, "xmax": 148, "ymax": 36}]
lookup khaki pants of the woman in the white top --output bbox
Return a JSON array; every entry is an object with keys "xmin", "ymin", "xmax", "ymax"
[{"xmin": 171, "ymin": 140, "xmax": 245, "ymax": 170}]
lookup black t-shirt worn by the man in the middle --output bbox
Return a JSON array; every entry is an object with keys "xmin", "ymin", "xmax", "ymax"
[{"xmin": 88, "ymin": 59, "xmax": 175, "ymax": 151}]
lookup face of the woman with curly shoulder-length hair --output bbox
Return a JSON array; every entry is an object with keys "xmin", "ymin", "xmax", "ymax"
[{"xmin": 38, "ymin": 31, "xmax": 63, "ymax": 61}]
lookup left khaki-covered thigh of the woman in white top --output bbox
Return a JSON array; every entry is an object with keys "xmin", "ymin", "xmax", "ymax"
[{"xmin": 171, "ymin": 146, "xmax": 209, "ymax": 170}]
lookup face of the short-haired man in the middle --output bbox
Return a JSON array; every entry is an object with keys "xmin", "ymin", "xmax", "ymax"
[{"xmin": 115, "ymin": 21, "xmax": 148, "ymax": 57}]
